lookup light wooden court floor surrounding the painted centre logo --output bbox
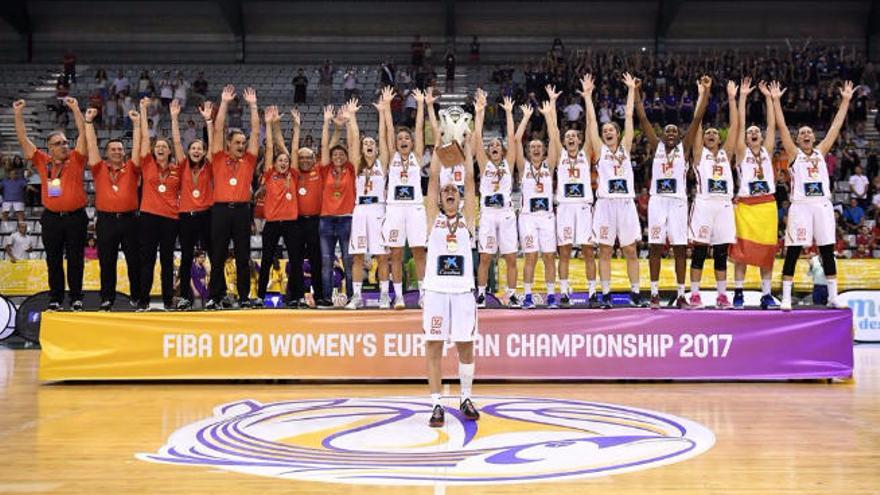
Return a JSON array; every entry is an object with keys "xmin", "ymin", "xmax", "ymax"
[{"xmin": 0, "ymin": 345, "xmax": 880, "ymax": 494}]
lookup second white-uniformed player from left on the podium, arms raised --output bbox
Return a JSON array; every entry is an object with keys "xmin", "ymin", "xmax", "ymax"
[{"xmin": 382, "ymin": 90, "xmax": 427, "ymax": 309}]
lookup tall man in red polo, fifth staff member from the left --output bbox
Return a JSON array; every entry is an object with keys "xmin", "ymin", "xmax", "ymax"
[{"xmin": 205, "ymin": 85, "xmax": 260, "ymax": 309}]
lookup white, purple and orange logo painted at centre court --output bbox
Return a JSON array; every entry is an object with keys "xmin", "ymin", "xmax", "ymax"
[{"xmin": 137, "ymin": 397, "xmax": 715, "ymax": 485}]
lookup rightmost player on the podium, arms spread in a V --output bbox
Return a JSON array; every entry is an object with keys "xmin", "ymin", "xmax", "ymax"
[{"xmin": 770, "ymin": 81, "xmax": 855, "ymax": 311}]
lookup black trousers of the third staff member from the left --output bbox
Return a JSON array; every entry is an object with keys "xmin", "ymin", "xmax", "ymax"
[{"xmin": 139, "ymin": 212, "xmax": 178, "ymax": 306}]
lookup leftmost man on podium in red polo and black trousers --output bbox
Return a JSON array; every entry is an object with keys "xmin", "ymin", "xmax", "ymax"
[{"xmin": 13, "ymin": 98, "xmax": 88, "ymax": 311}]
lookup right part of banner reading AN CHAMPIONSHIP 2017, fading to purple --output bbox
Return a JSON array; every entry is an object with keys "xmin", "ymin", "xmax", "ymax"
[{"xmin": 477, "ymin": 309, "xmax": 853, "ymax": 380}]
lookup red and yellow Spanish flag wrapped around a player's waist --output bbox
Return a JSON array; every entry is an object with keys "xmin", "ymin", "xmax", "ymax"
[{"xmin": 730, "ymin": 194, "xmax": 778, "ymax": 268}]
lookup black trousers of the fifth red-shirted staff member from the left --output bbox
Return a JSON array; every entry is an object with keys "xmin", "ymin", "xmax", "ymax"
[{"xmin": 208, "ymin": 203, "xmax": 252, "ymax": 301}]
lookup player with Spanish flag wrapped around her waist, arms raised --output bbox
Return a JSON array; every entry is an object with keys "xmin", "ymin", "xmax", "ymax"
[{"xmin": 728, "ymin": 81, "xmax": 779, "ymax": 309}]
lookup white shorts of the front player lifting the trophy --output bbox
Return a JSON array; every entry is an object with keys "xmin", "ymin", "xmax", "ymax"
[{"xmin": 422, "ymin": 290, "xmax": 477, "ymax": 342}]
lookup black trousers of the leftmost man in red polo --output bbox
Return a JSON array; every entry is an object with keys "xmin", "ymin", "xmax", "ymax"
[{"xmin": 40, "ymin": 209, "xmax": 89, "ymax": 304}]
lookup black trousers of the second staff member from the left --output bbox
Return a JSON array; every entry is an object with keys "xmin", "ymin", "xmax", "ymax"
[{"xmin": 95, "ymin": 211, "xmax": 142, "ymax": 303}]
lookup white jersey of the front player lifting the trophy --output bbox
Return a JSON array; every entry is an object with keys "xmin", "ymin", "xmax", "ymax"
[{"xmin": 424, "ymin": 213, "xmax": 474, "ymax": 294}]
